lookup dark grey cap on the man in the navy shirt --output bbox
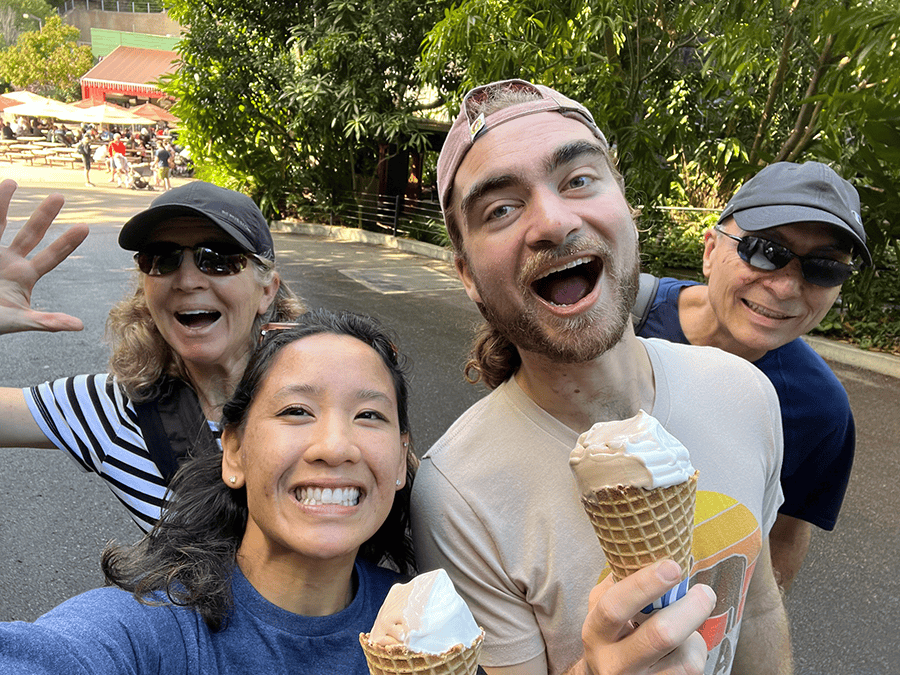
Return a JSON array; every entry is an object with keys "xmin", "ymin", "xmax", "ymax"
[{"xmin": 719, "ymin": 162, "xmax": 872, "ymax": 265}]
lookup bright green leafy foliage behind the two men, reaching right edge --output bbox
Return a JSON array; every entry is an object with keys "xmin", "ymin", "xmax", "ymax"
[{"xmin": 421, "ymin": 0, "xmax": 900, "ymax": 348}]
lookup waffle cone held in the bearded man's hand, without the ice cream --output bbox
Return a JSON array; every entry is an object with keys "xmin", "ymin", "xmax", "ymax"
[{"xmin": 581, "ymin": 471, "xmax": 698, "ymax": 581}]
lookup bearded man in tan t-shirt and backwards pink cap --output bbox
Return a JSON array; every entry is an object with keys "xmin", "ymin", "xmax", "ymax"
[{"xmin": 412, "ymin": 80, "xmax": 791, "ymax": 675}]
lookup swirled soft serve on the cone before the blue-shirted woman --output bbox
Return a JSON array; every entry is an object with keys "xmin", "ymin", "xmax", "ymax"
[{"xmin": 368, "ymin": 569, "xmax": 482, "ymax": 654}]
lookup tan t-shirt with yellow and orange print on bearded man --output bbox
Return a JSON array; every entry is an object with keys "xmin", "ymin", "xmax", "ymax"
[{"xmin": 412, "ymin": 339, "xmax": 783, "ymax": 674}]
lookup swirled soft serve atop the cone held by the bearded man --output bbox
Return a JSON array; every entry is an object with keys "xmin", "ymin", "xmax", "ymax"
[{"xmin": 569, "ymin": 410, "xmax": 694, "ymax": 495}]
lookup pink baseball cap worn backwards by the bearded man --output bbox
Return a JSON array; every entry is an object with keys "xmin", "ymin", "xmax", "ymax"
[{"xmin": 437, "ymin": 80, "xmax": 609, "ymax": 222}]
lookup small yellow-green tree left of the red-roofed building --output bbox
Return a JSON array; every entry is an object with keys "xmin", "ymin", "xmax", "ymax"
[{"xmin": 0, "ymin": 15, "xmax": 93, "ymax": 100}]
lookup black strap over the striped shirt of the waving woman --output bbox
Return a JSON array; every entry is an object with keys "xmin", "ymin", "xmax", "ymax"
[{"xmin": 134, "ymin": 377, "xmax": 219, "ymax": 485}]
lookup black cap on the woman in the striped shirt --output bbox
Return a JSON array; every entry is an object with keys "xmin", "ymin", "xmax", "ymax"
[{"xmin": 119, "ymin": 180, "xmax": 275, "ymax": 262}]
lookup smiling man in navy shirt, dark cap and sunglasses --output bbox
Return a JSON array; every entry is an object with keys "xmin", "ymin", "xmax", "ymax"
[{"xmin": 640, "ymin": 162, "xmax": 872, "ymax": 590}]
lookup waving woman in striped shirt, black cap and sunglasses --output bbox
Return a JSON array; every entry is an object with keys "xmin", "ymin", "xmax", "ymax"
[{"xmin": 0, "ymin": 180, "xmax": 303, "ymax": 531}]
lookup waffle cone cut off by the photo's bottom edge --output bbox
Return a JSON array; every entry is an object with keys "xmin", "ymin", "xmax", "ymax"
[{"xmin": 359, "ymin": 631, "xmax": 484, "ymax": 675}]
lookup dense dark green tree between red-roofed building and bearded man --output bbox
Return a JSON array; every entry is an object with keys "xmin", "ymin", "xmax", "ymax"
[{"xmin": 164, "ymin": 0, "xmax": 448, "ymax": 214}]
